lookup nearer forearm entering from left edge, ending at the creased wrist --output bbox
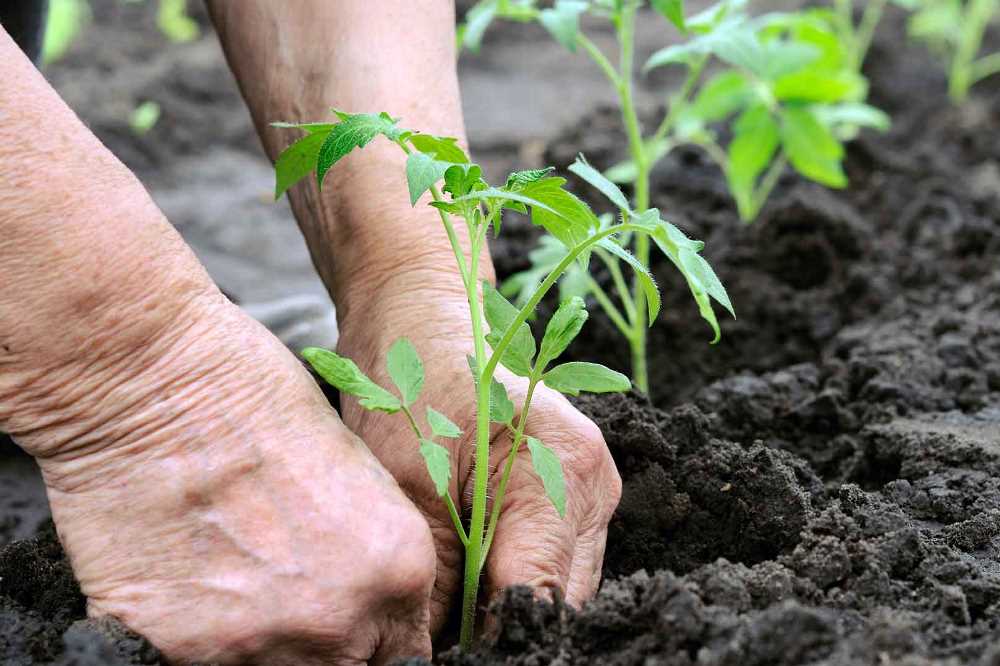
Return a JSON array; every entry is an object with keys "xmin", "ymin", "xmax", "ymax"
[{"xmin": 0, "ymin": 29, "xmax": 216, "ymax": 448}]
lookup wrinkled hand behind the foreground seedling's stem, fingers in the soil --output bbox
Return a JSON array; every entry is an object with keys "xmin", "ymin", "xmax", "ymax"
[{"xmin": 338, "ymin": 275, "xmax": 621, "ymax": 631}]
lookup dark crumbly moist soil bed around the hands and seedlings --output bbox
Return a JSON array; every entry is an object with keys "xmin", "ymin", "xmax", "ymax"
[{"xmin": 0, "ymin": 5, "xmax": 1000, "ymax": 666}]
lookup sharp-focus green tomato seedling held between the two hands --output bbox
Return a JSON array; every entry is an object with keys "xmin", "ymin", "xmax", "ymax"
[{"xmin": 275, "ymin": 111, "xmax": 730, "ymax": 648}]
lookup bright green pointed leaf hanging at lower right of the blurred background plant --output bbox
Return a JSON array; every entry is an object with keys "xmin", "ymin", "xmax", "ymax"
[{"xmin": 781, "ymin": 107, "xmax": 847, "ymax": 188}]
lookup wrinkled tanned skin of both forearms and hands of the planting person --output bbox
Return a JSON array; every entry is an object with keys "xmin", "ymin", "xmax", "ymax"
[{"xmin": 0, "ymin": 0, "xmax": 620, "ymax": 664}]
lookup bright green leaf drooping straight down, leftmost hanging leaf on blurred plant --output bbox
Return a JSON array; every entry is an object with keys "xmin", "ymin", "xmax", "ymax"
[{"xmin": 726, "ymin": 104, "xmax": 780, "ymax": 211}]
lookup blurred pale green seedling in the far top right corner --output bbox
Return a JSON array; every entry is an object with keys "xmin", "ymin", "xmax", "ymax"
[{"xmin": 897, "ymin": 0, "xmax": 1000, "ymax": 104}]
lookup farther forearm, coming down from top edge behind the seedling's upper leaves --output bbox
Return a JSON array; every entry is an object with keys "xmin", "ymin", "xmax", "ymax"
[{"xmin": 208, "ymin": 0, "xmax": 492, "ymax": 316}]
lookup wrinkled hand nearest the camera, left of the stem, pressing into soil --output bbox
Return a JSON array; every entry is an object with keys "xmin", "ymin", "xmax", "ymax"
[{"xmin": 0, "ymin": 290, "xmax": 435, "ymax": 665}]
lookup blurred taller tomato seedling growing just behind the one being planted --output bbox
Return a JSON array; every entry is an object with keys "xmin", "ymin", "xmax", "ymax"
[{"xmin": 459, "ymin": 0, "xmax": 888, "ymax": 393}]
